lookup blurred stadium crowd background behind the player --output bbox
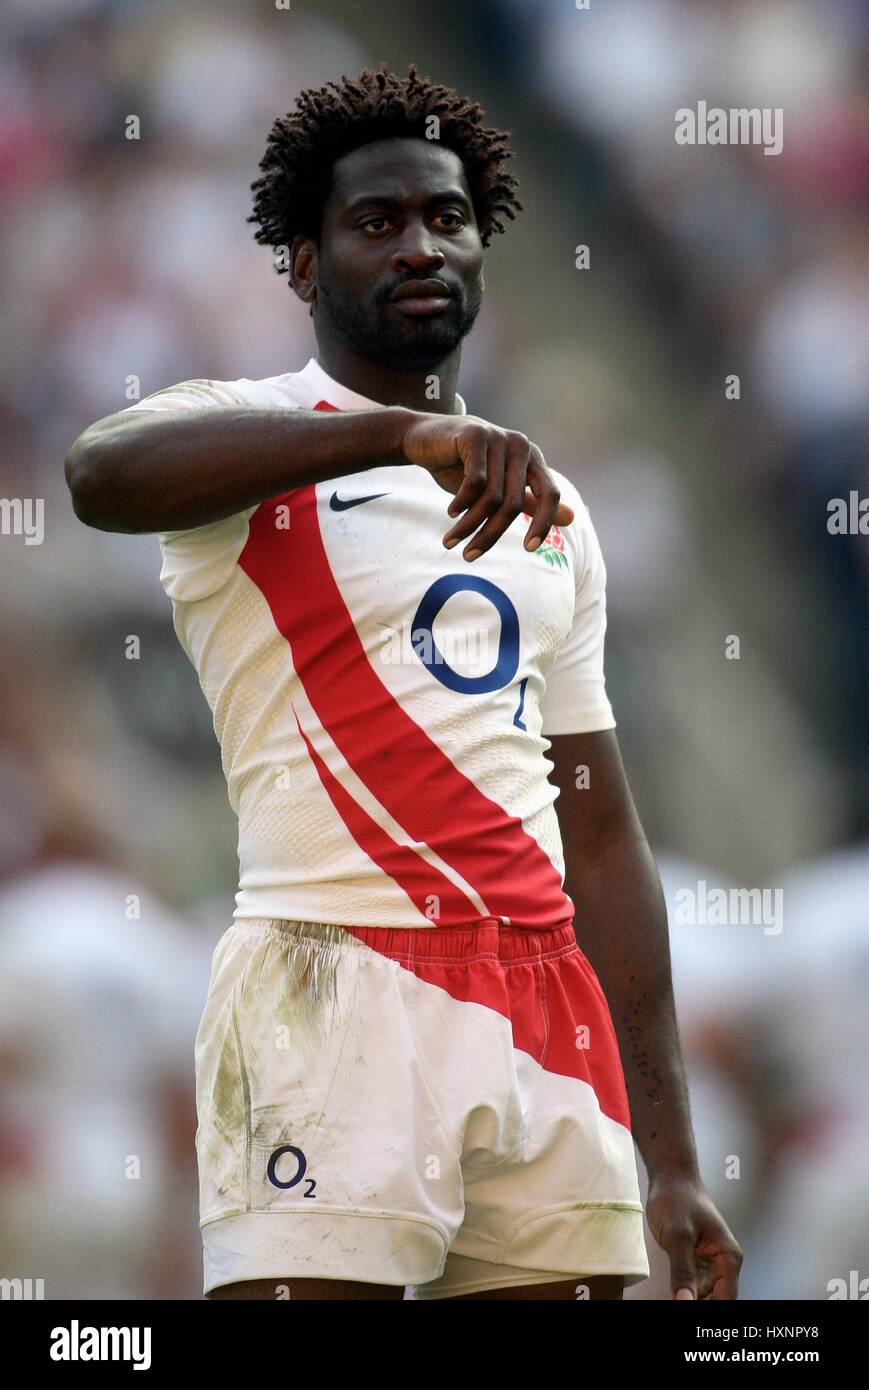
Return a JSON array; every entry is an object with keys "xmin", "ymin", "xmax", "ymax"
[{"xmin": 0, "ymin": 0, "xmax": 869, "ymax": 1300}]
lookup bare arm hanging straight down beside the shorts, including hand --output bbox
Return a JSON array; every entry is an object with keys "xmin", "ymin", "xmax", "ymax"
[{"xmin": 551, "ymin": 730, "xmax": 741, "ymax": 1298}]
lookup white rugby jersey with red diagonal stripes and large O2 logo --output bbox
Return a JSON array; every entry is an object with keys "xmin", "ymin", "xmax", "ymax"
[{"xmin": 122, "ymin": 359, "xmax": 615, "ymax": 927}]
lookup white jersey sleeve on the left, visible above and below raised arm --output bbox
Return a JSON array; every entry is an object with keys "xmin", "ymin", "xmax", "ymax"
[{"xmin": 122, "ymin": 378, "xmax": 265, "ymax": 603}]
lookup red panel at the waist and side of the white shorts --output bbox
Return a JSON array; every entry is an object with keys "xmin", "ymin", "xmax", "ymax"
[{"xmin": 343, "ymin": 927, "xmax": 631, "ymax": 1130}]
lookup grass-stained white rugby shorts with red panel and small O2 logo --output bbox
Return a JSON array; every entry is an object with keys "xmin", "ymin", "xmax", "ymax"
[{"xmin": 196, "ymin": 920, "xmax": 649, "ymax": 1300}]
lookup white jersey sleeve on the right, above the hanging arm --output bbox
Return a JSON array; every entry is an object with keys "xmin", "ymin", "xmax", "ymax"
[{"xmin": 541, "ymin": 475, "xmax": 616, "ymax": 735}]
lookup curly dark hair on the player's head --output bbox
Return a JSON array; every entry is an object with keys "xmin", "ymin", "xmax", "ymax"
[{"xmin": 247, "ymin": 63, "xmax": 523, "ymax": 262}]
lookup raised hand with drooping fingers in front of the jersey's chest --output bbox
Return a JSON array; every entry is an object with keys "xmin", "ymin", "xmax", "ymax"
[{"xmin": 402, "ymin": 411, "xmax": 573, "ymax": 560}]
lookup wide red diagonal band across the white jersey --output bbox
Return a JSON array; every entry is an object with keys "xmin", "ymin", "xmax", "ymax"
[{"xmin": 238, "ymin": 487, "xmax": 571, "ymax": 927}]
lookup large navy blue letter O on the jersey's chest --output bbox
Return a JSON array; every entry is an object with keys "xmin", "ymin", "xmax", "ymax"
[{"xmin": 410, "ymin": 574, "xmax": 524, "ymax": 695}]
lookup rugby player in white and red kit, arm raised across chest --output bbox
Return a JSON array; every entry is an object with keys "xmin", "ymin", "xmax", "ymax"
[{"xmin": 67, "ymin": 67, "xmax": 741, "ymax": 1300}]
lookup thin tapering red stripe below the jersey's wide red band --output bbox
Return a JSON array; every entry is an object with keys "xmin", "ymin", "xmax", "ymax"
[{"xmin": 293, "ymin": 709, "xmax": 480, "ymax": 927}]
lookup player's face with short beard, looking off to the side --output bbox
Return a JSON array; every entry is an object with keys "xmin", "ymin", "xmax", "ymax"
[{"xmin": 314, "ymin": 138, "xmax": 482, "ymax": 371}]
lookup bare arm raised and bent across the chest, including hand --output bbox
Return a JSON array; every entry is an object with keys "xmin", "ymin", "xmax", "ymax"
[{"xmin": 65, "ymin": 406, "xmax": 573, "ymax": 559}]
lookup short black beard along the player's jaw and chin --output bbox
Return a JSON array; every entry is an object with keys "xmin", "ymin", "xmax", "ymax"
[{"xmin": 317, "ymin": 279, "xmax": 482, "ymax": 371}]
